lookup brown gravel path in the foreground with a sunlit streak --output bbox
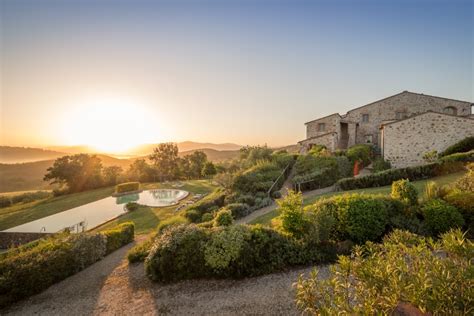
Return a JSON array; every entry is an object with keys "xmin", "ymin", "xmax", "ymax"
[{"xmin": 0, "ymin": 238, "xmax": 328, "ymax": 316}]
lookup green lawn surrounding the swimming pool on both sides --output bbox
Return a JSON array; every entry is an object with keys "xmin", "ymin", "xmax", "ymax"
[{"xmin": 0, "ymin": 180, "xmax": 215, "ymax": 232}]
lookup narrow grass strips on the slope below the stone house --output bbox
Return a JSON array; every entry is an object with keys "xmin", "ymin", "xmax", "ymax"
[{"xmin": 250, "ymin": 172, "xmax": 465, "ymax": 225}]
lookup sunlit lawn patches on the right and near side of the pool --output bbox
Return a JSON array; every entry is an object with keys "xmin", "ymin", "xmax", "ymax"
[{"xmin": 93, "ymin": 180, "xmax": 216, "ymax": 235}]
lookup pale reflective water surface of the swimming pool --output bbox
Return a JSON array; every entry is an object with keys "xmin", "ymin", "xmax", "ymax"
[{"xmin": 4, "ymin": 189, "xmax": 189, "ymax": 233}]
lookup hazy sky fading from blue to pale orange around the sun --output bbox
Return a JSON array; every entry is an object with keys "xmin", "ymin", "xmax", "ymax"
[{"xmin": 0, "ymin": 0, "xmax": 474, "ymax": 146}]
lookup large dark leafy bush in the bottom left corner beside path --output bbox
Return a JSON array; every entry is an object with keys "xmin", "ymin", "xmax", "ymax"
[{"xmin": 0, "ymin": 233, "xmax": 107, "ymax": 307}]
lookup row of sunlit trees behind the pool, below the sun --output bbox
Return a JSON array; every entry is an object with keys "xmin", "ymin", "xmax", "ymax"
[{"xmin": 43, "ymin": 143, "xmax": 219, "ymax": 193}]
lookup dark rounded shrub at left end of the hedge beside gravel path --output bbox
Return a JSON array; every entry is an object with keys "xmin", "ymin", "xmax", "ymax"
[{"xmin": 145, "ymin": 224, "xmax": 212, "ymax": 282}]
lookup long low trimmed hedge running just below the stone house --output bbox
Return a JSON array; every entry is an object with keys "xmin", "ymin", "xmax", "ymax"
[{"xmin": 336, "ymin": 162, "xmax": 464, "ymax": 191}]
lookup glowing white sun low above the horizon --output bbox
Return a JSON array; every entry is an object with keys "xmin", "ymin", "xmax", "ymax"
[{"xmin": 62, "ymin": 99, "xmax": 161, "ymax": 153}]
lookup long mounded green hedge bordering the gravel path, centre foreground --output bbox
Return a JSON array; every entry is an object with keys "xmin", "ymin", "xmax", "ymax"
[{"xmin": 145, "ymin": 224, "xmax": 335, "ymax": 282}]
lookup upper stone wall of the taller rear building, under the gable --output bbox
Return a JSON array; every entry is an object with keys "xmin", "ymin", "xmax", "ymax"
[{"xmin": 344, "ymin": 91, "xmax": 471, "ymax": 147}]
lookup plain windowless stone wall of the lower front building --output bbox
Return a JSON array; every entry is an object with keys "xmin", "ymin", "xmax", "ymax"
[{"xmin": 382, "ymin": 112, "xmax": 474, "ymax": 168}]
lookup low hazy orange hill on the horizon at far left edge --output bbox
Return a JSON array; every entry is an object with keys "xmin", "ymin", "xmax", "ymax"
[{"xmin": 0, "ymin": 146, "xmax": 65, "ymax": 163}]
